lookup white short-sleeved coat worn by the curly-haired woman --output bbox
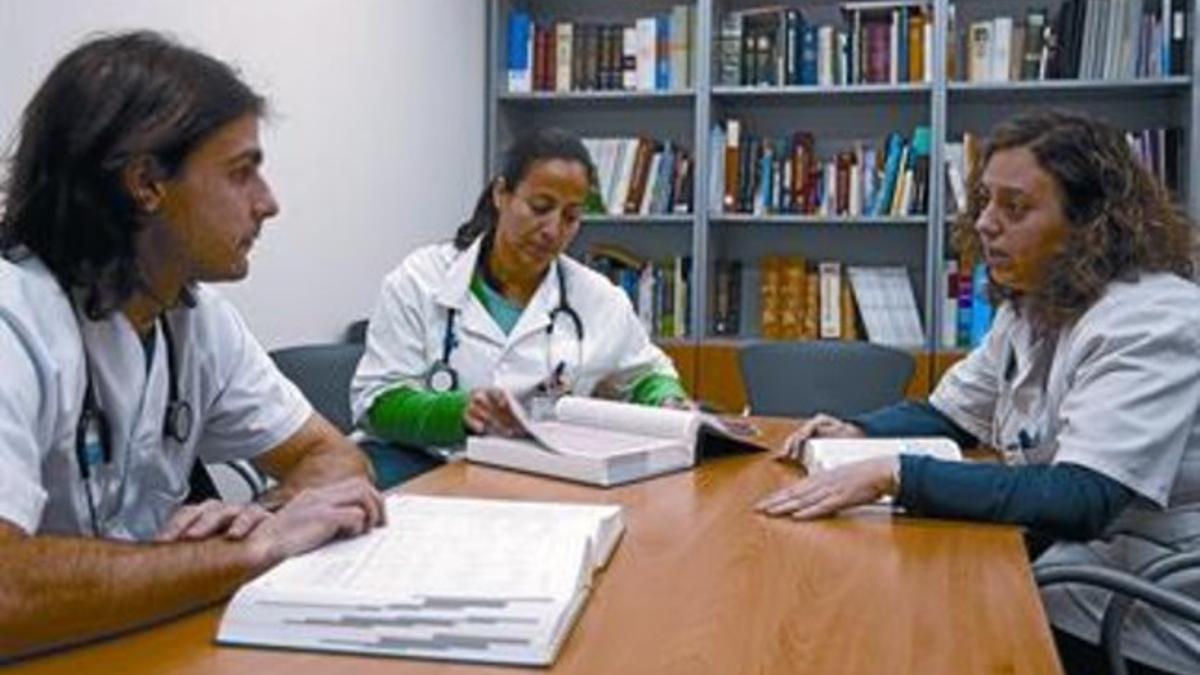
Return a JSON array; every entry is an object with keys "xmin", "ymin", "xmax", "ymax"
[{"xmin": 930, "ymin": 274, "xmax": 1200, "ymax": 671}]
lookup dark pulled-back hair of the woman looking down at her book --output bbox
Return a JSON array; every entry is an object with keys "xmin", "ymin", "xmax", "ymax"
[{"xmin": 454, "ymin": 127, "xmax": 596, "ymax": 250}]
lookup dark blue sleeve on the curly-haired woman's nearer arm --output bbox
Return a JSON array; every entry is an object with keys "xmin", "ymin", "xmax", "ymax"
[{"xmin": 896, "ymin": 455, "xmax": 1134, "ymax": 540}]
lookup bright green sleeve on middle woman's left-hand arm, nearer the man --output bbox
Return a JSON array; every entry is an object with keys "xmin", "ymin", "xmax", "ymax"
[{"xmin": 367, "ymin": 387, "xmax": 467, "ymax": 446}]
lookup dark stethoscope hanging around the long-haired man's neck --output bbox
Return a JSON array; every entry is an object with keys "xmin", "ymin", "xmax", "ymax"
[{"xmin": 74, "ymin": 316, "xmax": 194, "ymax": 537}]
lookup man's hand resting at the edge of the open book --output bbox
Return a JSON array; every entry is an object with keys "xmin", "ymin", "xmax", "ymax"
[{"xmin": 246, "ymin": 478, "xmax": 385, "ymax": 565}]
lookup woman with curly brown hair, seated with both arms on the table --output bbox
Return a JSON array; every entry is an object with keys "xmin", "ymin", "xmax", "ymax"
[{"xmin": 757, "ymin": 112, "xmax": 1200, "ymax": 673}]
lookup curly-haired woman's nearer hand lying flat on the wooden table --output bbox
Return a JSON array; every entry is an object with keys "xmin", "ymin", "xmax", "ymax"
[{"xmin": 755, "ymin": 456, "xmax": 900, "ymax": 520}]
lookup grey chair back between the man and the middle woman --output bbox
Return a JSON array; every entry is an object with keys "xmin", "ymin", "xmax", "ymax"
[{"xmin": 271, "ymin": 344, "xmax": 364, "ymax": 434}]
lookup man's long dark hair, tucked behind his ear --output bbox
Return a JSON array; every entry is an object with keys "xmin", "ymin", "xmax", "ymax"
[{"xmin": 0, "ymin": 31, "xmax": 266, "ymax": 318}]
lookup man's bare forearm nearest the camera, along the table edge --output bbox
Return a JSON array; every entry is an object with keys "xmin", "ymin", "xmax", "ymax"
[{"xmin": 0, "ymin": 526, "xmax": 277, "ymax": 663}]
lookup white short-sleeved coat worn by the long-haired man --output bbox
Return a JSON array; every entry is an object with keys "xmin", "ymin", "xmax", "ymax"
[{"xmin": 0, "ymin": 257, "xmax": 312, "ymax": 540}]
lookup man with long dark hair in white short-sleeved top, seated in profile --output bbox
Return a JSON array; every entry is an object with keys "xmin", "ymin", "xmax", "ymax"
[{"xmin": 0, "ymin": 32, "xmax": 382, "ymax": 662}]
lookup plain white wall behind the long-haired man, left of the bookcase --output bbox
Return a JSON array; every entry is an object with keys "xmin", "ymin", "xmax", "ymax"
[{"xmin": 0, "ymin": 0, "xmax": 486, "ymax": 347}]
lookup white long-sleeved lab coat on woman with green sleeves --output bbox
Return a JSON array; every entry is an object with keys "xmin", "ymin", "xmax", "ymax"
[{"xmin": 350, "ymin": 239, "xmax": 678, "ymax": 426}]
